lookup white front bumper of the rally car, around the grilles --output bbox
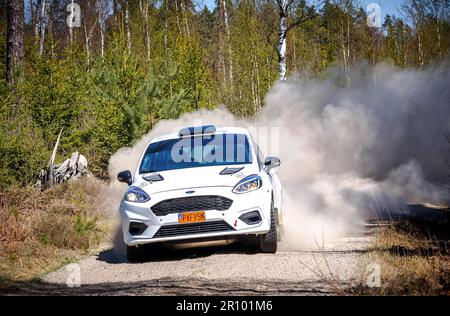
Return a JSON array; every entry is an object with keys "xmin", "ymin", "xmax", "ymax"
[{"xmin": 120, "ymin": 186, "xmax": 271, "ymax": 246}]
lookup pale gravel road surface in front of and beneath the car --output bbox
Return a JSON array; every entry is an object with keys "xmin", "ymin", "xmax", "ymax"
[{"xmin": 26, "ymin": 226, "xmax": 373, "ymax": 295}]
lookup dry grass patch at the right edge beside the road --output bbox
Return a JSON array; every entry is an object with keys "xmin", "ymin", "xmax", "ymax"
[{"xmin": 354, "ymin": 222, "xmax": 450, "ymax": 295}]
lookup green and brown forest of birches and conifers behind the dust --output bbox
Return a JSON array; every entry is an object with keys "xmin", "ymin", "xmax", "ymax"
[{"xmin": 0, "ymin": 0, "xmax": 450, "ymax": 189}]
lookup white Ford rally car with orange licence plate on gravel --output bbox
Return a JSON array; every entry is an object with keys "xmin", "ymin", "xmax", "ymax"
[{"xmin": 118, "ymin": 125, "xmax": 282, "ymax": 261}]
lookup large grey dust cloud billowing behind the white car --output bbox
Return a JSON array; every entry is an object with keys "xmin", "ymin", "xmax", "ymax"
[{"xmin": 104, "ymin": 65, "xmax": 450, "ymax": 250}]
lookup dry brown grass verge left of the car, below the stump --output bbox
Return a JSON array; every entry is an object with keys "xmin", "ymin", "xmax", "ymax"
[{"xmin": 0, "ymin": 179, "xmax": 108, "ymax": 285}]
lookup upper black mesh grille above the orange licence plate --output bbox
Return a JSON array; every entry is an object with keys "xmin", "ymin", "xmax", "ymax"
[{"xmin": 151, "ymin": 195, "xmax": 233, "ymax": 216}]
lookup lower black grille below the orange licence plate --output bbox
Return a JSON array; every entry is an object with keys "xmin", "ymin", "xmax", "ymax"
[{"xmin": 153, "ymin": 221, "xmax": 234, "ymax": 238}]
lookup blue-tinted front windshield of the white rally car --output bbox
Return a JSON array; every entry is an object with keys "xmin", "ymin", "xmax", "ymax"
[{"xmin": 139, "ymin": 134, "xmax": 252, "ymax": 174}]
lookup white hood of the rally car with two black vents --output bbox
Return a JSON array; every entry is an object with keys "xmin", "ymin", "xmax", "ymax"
[{"xmin": 133, "ymin": 164, "xmax": 259, "ymax": 194}]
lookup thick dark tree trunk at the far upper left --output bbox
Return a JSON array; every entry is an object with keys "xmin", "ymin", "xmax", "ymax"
[{"xmin": 6, "ymin": 0, "xmax": 24, "ymax": 83}]
